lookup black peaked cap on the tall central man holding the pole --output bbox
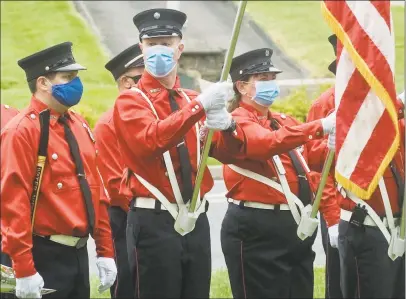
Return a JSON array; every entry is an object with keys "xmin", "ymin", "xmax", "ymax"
[{"xmin": 133, "ymin": 8, "xmax": 186, "ymax": 40}]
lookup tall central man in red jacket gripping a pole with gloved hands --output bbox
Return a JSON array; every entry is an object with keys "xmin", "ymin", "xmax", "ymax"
[{"xmin": 113, "ymin": 9, "xmax": 233, "ymax": 298}]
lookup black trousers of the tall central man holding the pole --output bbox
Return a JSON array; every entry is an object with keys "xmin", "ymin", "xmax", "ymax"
[{"xmin": 127, "ymin": 205, "xmax": 211, "ymax": 298}]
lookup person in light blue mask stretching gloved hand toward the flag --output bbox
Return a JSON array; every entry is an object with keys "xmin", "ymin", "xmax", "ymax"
[{"xmin": 206, "ymin": 48, "xmax": 335, "ymax": 298}]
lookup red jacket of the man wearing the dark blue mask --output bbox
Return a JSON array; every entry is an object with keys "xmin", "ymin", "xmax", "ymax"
[{"xmin": 0, "ymin": 97, "xmax": 114, "ymax": 278}]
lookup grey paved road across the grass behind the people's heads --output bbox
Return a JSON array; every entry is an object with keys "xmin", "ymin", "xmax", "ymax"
[{"xmin": 74, "ymin": 1, "xmax": 307, "ymax": 79}]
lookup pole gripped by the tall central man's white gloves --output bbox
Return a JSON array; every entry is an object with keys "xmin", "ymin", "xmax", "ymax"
[{"xmin": 189, "ymin": 0, "xmax": 247, "ymax": 213}]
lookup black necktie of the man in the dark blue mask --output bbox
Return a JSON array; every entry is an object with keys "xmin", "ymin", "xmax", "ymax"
[{"xmin": 58, "ymin": 116, "xmax": 95, "ymax": 234}]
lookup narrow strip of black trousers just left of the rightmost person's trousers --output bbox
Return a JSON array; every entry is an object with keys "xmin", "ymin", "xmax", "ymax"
[{"xmin": 320, "ymin": 217, "xmax": 343, "ymax": 299}]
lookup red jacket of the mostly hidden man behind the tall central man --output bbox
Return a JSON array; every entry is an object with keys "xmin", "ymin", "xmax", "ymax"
[{"xmin": 94, "ymin": 108, "xmax": 129, "ymax": 212}]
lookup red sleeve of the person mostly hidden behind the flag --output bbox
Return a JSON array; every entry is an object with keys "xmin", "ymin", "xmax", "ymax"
[{"xmin": 307, "ymin": 87, "xmax": 340, "ymax": 227}]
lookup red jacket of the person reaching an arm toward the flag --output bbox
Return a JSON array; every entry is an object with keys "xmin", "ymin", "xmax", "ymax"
[{"xmin": 212, "ymin": 103, "xmax": 323, "ymax": 204}]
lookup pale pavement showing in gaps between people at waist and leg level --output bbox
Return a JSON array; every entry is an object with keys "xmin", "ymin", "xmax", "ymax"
[{"xmin": 89, "ymin": 180, "xmax": 325, "ymax": 274}]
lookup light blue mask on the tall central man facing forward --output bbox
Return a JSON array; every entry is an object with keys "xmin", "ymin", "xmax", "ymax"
[{"xmin": 144, "ymin": 45, "xmax": 176, "ymax": 78}]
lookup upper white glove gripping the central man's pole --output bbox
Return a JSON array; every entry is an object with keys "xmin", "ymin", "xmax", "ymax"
[{"xmin": 196, "ymin": 82, "xmax": 234, "ymax": 112}]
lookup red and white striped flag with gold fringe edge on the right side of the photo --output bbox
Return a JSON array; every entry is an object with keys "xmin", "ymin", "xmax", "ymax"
[{"xmin": 322, "ymin": 1, "xmax": 399, "ymax": 199}]
